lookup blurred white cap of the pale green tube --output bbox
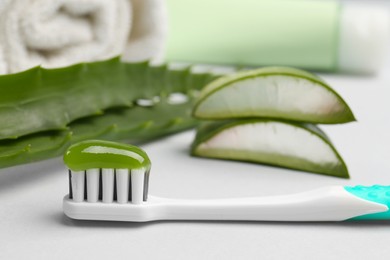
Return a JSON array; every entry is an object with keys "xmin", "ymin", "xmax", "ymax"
[{"xmin": 338, "ymin": 4, "xmax": 390, "ymax": 74}]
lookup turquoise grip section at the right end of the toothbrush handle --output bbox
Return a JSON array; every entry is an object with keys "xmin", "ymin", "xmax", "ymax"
[{"xmin": 344, "ymin": 185, "xmax": 390, "ymax": 220}]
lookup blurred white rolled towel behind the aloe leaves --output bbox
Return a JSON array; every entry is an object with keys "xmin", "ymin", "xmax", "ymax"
[{"xmin": 0, "ymin": 0, "xmax": 167, "ymax": 74}]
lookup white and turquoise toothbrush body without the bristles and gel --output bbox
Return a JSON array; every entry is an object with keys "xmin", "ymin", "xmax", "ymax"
[{"xmin": 63, "ymin": 185, "xmax": 390, "ymax": 222}]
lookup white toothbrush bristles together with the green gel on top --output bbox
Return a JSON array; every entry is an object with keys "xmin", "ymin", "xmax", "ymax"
[{"xmin": 64, "ymin": 140, "xmax": 151, "ymax": 204}]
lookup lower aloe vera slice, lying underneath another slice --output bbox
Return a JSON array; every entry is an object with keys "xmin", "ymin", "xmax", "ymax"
[{"xmin": 191, "ymin": 119, "xmax": 349, "ymax": 178}]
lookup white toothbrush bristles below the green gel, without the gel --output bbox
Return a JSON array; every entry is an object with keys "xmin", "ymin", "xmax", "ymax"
[{"xmin": 69, "ymin": 168, "xmax": 149, "ymax": 204}]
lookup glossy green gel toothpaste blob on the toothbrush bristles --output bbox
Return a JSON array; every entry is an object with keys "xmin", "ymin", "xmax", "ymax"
[{"xmin": 64, "ymin": 140, "xmax": 151, "ymax": 171}]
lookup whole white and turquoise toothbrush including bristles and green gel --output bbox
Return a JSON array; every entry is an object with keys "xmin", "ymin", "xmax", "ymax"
[{"xmin": 63, "ymin": 140, "xmax": 390, "ymax": 222}]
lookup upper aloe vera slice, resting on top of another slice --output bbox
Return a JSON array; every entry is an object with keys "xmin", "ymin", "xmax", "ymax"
[{"xmin": 193, "ymin": 67, "xmax": 355, "ymax": 124}]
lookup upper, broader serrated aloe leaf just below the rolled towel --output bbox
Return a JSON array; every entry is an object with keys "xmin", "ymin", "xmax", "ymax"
[{"xmin": 0, "ymin": 58, "xmax": 219, "ymax": 140}]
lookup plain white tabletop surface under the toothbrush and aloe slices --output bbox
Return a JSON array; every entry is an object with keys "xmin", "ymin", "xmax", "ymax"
[{"xmin": 0, "ymin": 0, "xmax": 390, "ymax": 260}]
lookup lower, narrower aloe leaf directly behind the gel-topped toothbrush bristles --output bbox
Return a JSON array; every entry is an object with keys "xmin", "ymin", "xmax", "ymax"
[{"xmin": 0, "ymin": 100, "xmax": 197, "ymax": 168}]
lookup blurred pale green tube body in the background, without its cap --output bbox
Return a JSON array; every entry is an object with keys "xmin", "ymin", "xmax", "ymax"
[{"xmin": 166, "ymin": 0, "xmax": 340, "ymax": 71}]
